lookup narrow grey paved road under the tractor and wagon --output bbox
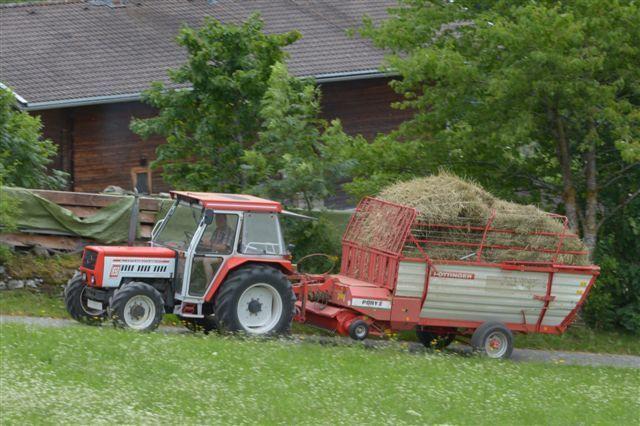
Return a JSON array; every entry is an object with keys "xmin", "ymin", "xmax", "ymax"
[{"xmin": 0, "ymin": 315, "xmax": 640, "ymax": 369}]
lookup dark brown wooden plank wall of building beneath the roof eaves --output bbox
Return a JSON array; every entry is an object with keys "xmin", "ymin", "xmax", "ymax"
[{"xmin": 38, "ymin": 78, "xmax": 411, "ymax": 193}]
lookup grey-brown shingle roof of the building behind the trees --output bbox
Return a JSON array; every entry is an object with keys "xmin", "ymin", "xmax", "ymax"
[{"xmin": 0, "ymin": 0, "xmax": 395, "ymax": 107}]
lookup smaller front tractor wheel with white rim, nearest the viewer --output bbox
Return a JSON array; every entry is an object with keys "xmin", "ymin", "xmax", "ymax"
[{"xmin": 109, "ymin": 281, "xmax": 164, "ymax": 331}]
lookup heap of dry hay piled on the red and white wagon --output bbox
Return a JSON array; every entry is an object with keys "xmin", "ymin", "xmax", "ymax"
[{"xmin": 378, "ymin": 173, "xmax": 589, "ymax": 265}]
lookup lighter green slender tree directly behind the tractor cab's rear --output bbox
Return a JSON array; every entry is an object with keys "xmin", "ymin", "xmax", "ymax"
[{"xmin": 243, "ymin": 63, "xmax": 354, "ymax": 210}]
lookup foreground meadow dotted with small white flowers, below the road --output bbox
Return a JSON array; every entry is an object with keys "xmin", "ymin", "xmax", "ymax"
[{"xmin": 0, "ymin": 324, "xmax": 640, "ymax": 424}]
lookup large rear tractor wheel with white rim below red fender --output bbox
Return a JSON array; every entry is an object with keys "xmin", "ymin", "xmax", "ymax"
[{"xmin": 214, "ymin": 265, "xmax": 296, "ymax": 335}]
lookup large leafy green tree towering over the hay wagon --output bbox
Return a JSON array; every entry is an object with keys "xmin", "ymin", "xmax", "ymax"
[{"xmin": 352, "ymin": 0, "xmax": 640, "ymax": 255}]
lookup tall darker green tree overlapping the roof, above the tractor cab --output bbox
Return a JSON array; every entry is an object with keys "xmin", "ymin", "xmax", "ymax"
[{"xmin": 131, "ymin": 15, "xmax": 299, "ymax": 192}]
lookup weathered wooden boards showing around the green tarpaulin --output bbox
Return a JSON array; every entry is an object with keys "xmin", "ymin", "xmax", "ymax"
[{"xmin": 0, "ymin": 190, "xmax": 165, "ymax": 250}]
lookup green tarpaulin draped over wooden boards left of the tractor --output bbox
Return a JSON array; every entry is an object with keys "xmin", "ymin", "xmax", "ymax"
[{"xmin": 0, "ymin": 187, "xmax": 135, "ymax": 244}]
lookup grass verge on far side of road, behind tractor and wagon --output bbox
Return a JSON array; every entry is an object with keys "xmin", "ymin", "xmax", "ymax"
[{"xmin": 0, "ymin": 288, "xmax": 640, "ymax": 355}]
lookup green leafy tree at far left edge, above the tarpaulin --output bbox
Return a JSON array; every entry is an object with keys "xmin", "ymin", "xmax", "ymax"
[{"xmin": 0, "ymin": 89, "xmax": 66, "ymax": 189}]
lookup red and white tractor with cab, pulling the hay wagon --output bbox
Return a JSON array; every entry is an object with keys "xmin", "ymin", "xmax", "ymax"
[{"xmin": 65, "ymin": 191, "xmax": 295, "ymax": 334}]
